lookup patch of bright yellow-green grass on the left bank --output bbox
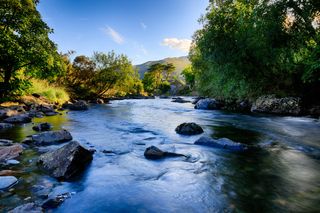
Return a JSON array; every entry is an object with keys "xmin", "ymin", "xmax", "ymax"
[{"xmin": 29, "ymin": 79, "xmax": 69, "ymax": 104}]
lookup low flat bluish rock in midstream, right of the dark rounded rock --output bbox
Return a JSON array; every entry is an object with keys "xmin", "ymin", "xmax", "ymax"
[{"xmin": 194, "ymin": 136, "xmax": 248, "ymax": 152}]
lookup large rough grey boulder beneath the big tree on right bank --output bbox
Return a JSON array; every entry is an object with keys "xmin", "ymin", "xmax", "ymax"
[{"xmin": 251, "ymin": 95, "xmax": 301, "ymax": 115}]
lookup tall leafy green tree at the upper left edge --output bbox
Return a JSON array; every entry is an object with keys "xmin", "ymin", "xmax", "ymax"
[{"xmin": 0, "ymin": 0, "xmax": 65, "ymax": 96}]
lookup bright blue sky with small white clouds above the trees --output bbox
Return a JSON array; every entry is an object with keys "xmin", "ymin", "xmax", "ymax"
[{"xmin": 38, "ymin": 0, "xmax": 209, "ymax": 64}]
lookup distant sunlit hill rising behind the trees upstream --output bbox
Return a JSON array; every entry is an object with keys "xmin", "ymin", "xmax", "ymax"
[{"xmin": 136, "ymin": 56, "xmax": 191, "ymax": 79}]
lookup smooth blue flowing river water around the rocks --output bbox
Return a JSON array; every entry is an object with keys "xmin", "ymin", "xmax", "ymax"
[{"xmin": 0, "ymin": 99, "xmax": 320, "ymax": 213}]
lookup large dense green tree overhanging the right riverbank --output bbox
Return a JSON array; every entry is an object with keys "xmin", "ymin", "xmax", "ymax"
[{"xmin": 189, "ymin": 0, "xmax": 320, "ymax": 98}]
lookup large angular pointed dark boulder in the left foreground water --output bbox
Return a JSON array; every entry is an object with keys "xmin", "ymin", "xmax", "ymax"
[{"xmin": 38, "ymin": 141, "xmax": 92, "ymax": 180}]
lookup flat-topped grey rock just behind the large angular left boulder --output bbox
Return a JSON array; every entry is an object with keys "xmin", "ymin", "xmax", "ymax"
[{"xmin": 24, "ymin": 129, "xmax": 72, "ymax": 146}]
